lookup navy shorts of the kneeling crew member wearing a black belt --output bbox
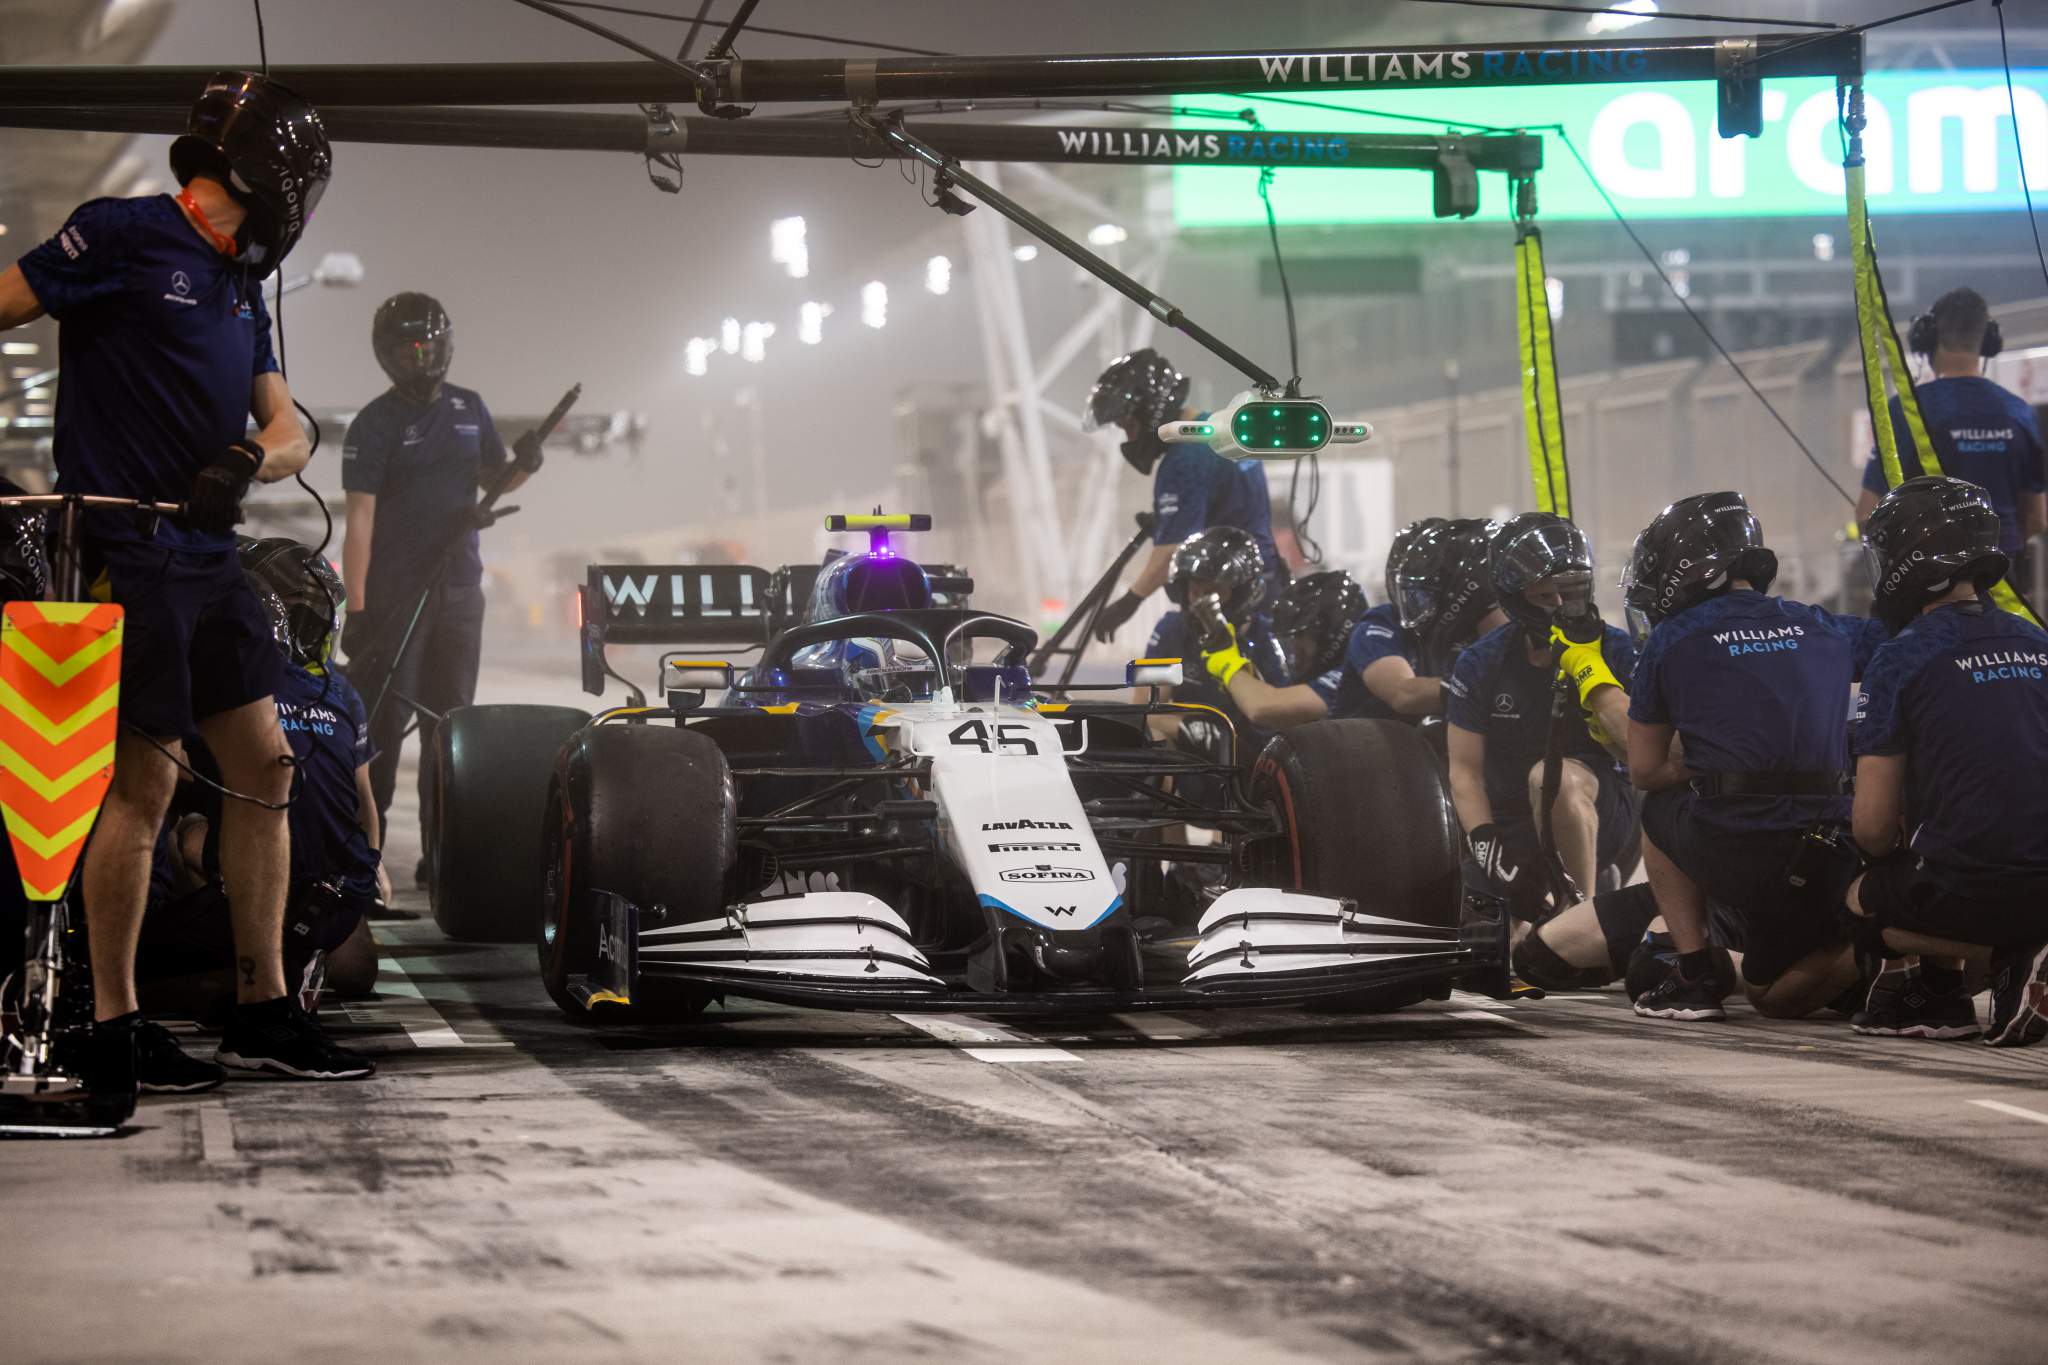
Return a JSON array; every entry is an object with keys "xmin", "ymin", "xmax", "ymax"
[{"xmin": 1642, "ymin": 786, "xmax": 1847, "ymax": 986}]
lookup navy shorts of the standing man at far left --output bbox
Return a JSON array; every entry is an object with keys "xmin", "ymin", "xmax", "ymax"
[{"xmin": 84, "ymin": 540, "xmax": 285, "ymax": 741}]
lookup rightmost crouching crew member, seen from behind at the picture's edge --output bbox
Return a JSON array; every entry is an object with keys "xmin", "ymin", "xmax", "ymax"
[{"xmin": 1847, "ymin": 479, "xmax": 2048, "ymax": 1046}]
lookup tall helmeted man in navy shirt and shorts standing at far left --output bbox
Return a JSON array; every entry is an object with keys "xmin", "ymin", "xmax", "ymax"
[{"xmin": 0, "ymin": 72, "xmax": 371, "ymax": 1091}]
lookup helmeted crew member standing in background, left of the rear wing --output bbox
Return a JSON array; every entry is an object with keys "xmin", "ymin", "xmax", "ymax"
[{"xmin": 342, "ymin": 293, "xmax": 541, "ymax": 886}]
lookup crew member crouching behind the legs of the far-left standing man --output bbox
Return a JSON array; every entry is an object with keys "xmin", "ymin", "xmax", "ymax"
[{"xmin": 139, "ymin": 538, "xmax": 381, "ymax": 1019}]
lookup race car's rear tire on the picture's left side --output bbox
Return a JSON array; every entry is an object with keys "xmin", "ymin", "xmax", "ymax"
[{"xmin": 428, "ymin": 706, "xmax": 590, "ymax": 943}]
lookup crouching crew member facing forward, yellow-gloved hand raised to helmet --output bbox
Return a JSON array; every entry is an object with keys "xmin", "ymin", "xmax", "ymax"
[{"xmin": 1450, "ymin": 512, "xmax": 1636, "ymax": 919}]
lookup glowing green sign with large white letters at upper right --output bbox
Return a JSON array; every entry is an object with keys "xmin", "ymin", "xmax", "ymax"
[{"xmin": 1174, "ymin": 68, "xmax": 2048, "ymax": 227}]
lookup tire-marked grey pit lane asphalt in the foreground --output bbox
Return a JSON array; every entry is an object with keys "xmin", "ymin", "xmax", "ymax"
[{"xmin": 0, "ymin": 667, "xmax": 2048, "ymax": 1365}]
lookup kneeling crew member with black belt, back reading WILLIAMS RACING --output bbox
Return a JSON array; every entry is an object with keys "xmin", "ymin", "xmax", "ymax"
[{"xmin": 1624, "ymin": 493, "xmax": 1884, "ymax": 1019}]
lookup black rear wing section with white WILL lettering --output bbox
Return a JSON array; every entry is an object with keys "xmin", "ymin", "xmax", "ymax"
[{"xmin": 575, "ymin": 565, "xmax": 770, "ymax": 696}]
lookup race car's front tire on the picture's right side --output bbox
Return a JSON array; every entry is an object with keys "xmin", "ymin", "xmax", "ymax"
[{"xmin": 1251, "ymin": 720, "xmax": 1462, "ymax": 1009}]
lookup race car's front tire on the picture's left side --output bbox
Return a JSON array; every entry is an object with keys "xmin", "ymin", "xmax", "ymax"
[{"xmin": 539, "ymin": 724, "xmax": 739, "ymax": 1023}]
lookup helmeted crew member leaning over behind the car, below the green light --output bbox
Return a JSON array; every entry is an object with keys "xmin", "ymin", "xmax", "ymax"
[{"xmin": 1087, "ymin": 348, "xmax": 1286, "ymax": 659}]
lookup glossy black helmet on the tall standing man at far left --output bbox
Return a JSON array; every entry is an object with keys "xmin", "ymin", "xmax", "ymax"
[{"xmin": 170, "ymin": 72, "xmax": 334, "ymax": 280}]
